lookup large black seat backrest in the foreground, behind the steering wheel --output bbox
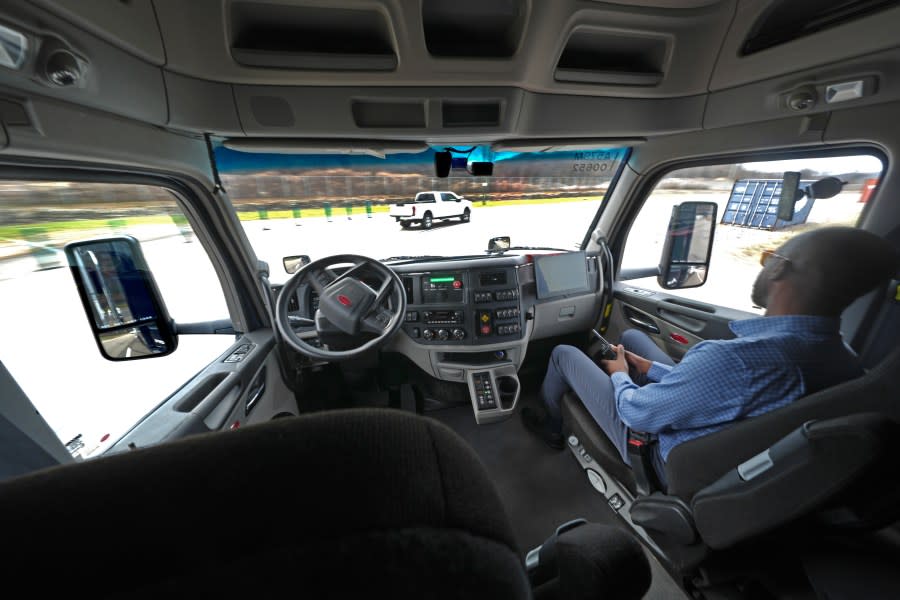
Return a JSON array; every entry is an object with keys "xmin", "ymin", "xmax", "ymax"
[{"xmin": 0, "ymin": 409, "xmax": 531, "ymax": 598}]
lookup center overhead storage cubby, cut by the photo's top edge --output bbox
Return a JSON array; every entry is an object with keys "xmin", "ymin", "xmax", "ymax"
[{"xmin": 422, "ymin": 0, "xmax": 527, "ymax": 58}]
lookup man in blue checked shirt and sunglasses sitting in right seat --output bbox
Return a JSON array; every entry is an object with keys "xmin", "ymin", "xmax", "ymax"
[{"xmin": 522, "ymin": 227, "xmax": 900, "ymax": 486}]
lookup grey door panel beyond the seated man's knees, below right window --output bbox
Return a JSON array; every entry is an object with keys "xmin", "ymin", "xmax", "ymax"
[{"xmin": 607, "ymin": 282, "xmax": 756, "ymax": 361}]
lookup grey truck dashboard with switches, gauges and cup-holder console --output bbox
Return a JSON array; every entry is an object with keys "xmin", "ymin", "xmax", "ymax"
[{"xmin": 280, "ymin": 252, "xmax": 603, "ymax": 423}]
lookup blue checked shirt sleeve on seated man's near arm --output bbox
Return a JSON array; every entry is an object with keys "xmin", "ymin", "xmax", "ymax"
[{"xmin": 611, "ymin": 342, "xmax": 750, "ymax": 433}]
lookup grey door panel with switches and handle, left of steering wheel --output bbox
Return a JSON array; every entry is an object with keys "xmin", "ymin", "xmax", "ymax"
[{"xmin": 108, "ymin": 329, "xmax": 297, "ymax": 453}]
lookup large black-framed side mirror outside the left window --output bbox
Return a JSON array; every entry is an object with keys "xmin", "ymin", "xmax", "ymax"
[{"xmin": 65, "ymin": 236, "xmax": 178, "ymax": 360}]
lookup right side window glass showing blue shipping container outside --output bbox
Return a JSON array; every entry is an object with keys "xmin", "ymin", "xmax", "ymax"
[{"xmin": 622, "ymin": 155, "xmax": 884, "ymax": 314}]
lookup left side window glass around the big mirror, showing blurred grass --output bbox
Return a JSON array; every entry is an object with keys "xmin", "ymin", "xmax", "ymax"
[{"xmin": 0, "ymin": 181, "xmax": 234, "ymax": 458}]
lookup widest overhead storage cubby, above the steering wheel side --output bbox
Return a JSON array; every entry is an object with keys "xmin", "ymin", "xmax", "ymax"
[{"xmin": 231, "ymin": 2, "xmax": 397, "ymax": 71}]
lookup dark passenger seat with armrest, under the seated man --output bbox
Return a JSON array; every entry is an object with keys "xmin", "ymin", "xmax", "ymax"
[{"xmin": 562, "ymin": 340, "xmax": 900, "ymax": 572}]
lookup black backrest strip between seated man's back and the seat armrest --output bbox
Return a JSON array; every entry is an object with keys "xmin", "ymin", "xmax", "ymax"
[{"xmin": 666, "ymin": 346, "xmax": 900, "ymax": 502}]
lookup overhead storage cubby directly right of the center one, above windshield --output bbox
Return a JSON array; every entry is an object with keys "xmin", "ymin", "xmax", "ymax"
[{"xmin": 554, "ymin": 28, "xmax": 669, "ymax": 86}]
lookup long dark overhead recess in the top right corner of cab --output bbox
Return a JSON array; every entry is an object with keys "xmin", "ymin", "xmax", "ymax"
[{"xmin": 741, "ymin": 0, "xmax": 897, "ymax": 56}]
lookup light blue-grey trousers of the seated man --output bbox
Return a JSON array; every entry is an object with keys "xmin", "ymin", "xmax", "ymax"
[{"xmin": 541, "ymin": 329, "xmax": 675, "ymax": 477}]
